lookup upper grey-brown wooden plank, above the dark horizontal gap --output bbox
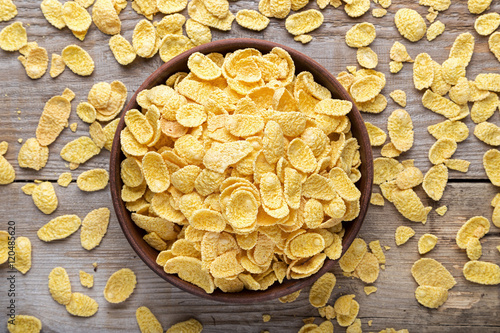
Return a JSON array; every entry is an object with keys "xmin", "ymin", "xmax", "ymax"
[{"xmin": 0, "ymin": 0, "xmax": 500, "ymax": 180}]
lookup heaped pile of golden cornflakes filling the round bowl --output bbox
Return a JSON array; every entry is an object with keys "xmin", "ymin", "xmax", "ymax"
[{"xmin": 120, "ymin": 48, "xmax": 364, "ymax": 293}]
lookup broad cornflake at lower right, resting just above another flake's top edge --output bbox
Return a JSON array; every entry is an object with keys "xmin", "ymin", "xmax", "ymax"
[{"xmin": 411, "ymin": 258, "xmax": 457, "ymax": 289}]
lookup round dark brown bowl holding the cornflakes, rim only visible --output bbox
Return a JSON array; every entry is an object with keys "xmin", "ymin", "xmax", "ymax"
[{"xmin": 110, "ymin": 38, "xmax": 373, "ymax": 303}]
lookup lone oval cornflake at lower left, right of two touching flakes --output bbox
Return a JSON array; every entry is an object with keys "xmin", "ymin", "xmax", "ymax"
[{"xmin": 104, "ymin": 268, "xmax": 137, "ymax": 303}]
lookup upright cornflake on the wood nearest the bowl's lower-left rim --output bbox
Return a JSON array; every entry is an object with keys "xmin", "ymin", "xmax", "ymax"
[{"xmin": 80, "ymin": 207, "xmax": 110, "ymax": 251}]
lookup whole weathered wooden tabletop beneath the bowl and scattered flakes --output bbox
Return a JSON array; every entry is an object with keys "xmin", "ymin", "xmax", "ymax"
[{"xmin": 0, "ymin": 0, "xmax": 500, "ymax": 333}]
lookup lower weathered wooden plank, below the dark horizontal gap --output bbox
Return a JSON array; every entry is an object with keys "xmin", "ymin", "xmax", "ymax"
[{"xmin": 0, "ymin": 183, "xmax": 500, "ymax": 332}]
